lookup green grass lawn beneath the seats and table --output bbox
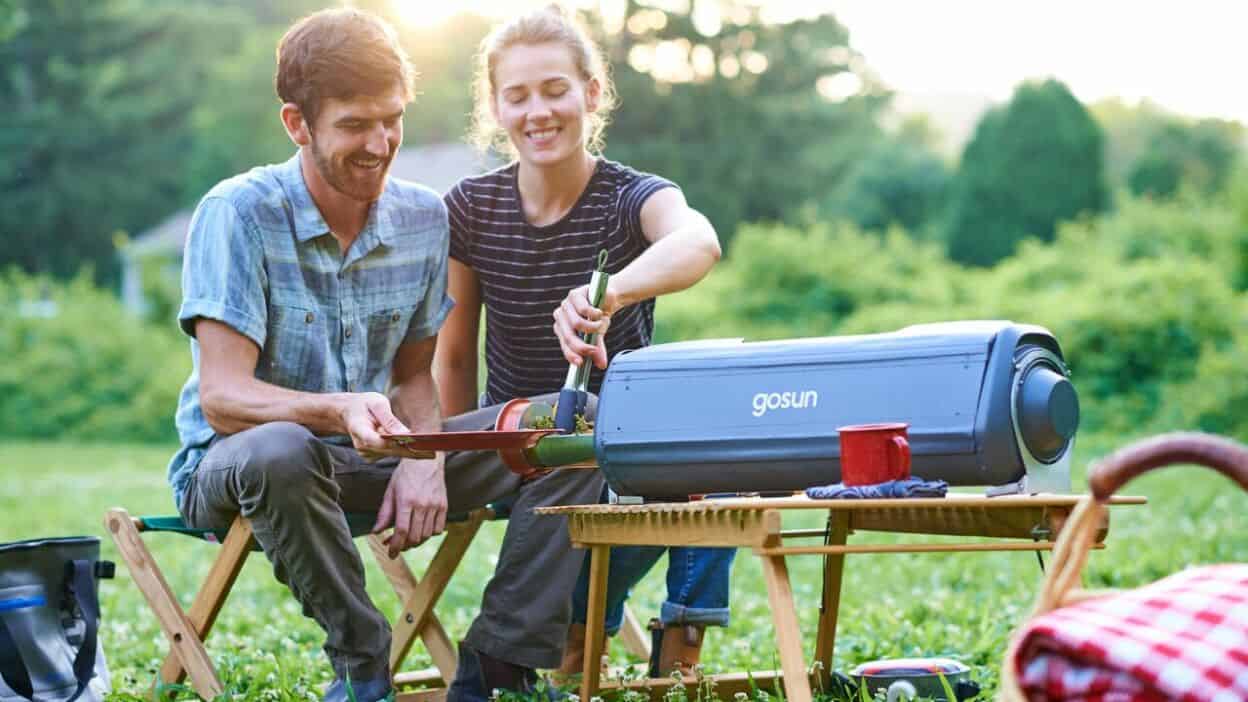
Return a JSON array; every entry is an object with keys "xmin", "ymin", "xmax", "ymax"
[{"xmin": 0, "ymin": 437, "xmax": 1248, "ymax": 700}]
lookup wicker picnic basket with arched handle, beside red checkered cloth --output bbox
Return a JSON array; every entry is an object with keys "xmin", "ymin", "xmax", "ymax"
[{"xmin": 1000, "ymin": 432, "xmax": 1248, "ymax": 702}]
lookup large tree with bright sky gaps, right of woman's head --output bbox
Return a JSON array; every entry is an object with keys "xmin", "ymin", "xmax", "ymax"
[{"xmin": 592, "ymin": 1, "xmax": 887, "ymax": 241}]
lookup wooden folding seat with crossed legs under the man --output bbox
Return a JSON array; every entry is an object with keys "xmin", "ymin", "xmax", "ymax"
[{"xmin": 105, "ymin": 507, "xmax": 649, "ymax": 702}]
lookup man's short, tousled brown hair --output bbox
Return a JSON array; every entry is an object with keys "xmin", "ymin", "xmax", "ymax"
[{"xmin": 273, "ymin": 7, "xmax": 416, "ymax": 129}]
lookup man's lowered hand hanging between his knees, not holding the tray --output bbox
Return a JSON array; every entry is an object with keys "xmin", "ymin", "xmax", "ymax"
[{"xmin": 373, "ymin": 455, "xmax": 447, "ymax": 558}]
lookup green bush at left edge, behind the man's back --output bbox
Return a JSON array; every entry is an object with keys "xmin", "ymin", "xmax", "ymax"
[{"xmin": 0, "ymin": 271, "xmax": 190, "ymax": 441}]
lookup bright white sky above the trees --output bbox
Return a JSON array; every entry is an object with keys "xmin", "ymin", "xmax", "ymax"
[{"xmin": 393, "ymin": 0, "xmax": 1248, "ymax": 124}]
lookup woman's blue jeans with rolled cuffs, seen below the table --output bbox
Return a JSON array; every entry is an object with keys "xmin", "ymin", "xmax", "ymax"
[{"xmin": 572, "ymin": 546, "xmax": 736, "ymax": 635}]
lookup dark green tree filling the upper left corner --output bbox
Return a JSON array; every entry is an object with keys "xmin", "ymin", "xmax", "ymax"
[{"xmin": 0, "ymin": 0, "xmax": 234, "ymax": 280}]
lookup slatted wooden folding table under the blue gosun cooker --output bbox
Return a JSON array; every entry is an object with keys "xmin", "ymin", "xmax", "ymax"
[{"xmin": 538, "ymin": 493, "xmax": 1144, "ymax": 702}]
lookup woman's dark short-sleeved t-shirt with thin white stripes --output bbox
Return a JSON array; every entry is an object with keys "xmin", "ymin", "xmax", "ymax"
[{"xmin": 444, "ymin": 159, "xmax": 675, "ymax": 403}]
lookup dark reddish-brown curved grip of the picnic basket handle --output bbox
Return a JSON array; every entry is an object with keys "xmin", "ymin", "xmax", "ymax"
[{"xmin": 1088, "ymin": 432, "xmax": 1248, "ymax": 502}]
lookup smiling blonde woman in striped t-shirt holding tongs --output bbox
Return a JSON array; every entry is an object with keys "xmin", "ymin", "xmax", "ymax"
[{"xmin": 436, "ymin": 6, "xmax": 734, "ymax": 673}]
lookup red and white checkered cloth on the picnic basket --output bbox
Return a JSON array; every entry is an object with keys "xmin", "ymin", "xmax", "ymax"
[{"xmin": 1013, "ymin": 565, "xmax": 1248, "ymax": 702}]
